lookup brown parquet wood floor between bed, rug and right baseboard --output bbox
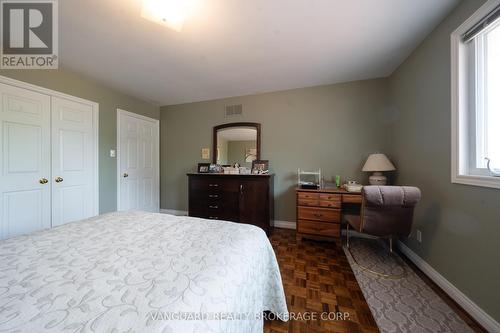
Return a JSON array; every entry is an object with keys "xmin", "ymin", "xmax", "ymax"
[{"xmin": 264, "ymin": 228, "xmax": 486, "ymax": 333}]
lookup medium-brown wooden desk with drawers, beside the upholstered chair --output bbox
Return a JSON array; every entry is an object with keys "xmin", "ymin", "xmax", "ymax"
[{"xmin": 296, "ymin": 188, "xmax": 361, "ymax": 238}]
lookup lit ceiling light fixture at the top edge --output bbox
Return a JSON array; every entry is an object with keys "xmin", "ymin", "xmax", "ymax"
[{"xmin": 141, "ymin": 0, "xmax": 198, "ymax": 31}]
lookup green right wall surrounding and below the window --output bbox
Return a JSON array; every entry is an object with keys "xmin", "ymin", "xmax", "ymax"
[{"xmin": 389, "ymin": 0, "xmax": 500, "ymax": 321}]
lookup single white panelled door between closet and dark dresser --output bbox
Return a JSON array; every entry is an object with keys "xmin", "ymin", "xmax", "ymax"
[{"xmin": 117, "ymin": 110, "xmax": 160, "ymax": 212}]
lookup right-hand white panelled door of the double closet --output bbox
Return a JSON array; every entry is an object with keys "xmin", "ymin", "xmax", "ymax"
[{"xmin": 51, "ymin": 97, "xmax": 96, "ymax": 226}]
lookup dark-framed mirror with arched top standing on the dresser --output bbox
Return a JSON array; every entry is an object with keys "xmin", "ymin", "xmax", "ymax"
[{"xmin": 212, "ymin": 123, "xmax": 260, "ymax": 165}]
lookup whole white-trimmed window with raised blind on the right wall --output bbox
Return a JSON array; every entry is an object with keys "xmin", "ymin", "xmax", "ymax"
[{"xmin": 451, "ymin": 0, "xmax": 500, "ymax": 188}]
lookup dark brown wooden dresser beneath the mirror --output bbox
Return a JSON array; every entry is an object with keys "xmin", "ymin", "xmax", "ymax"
[{"xmin": 188, "ymin": 173, "xmax": 274, "ymax": 232}]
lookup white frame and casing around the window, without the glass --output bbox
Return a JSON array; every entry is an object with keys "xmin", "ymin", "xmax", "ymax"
[{"xmin": 451, "ymin": 0, "xmax": 500, "ymax": 188}]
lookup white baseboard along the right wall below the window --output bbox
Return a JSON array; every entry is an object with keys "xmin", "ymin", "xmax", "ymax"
[{"xmin": 398, "ymin": 242, "xmax": 500, "ymax": 332}]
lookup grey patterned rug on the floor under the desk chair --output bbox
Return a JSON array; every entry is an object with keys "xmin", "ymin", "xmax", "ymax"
[{"xmin": 344, "ymin": 238, "xmax": 473, "ymax": 333}]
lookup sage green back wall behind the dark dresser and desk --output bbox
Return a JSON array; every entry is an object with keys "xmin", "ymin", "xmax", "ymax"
[{"xmin": 160, "ymin": 79, "xmax": 388, "ymax": 221}]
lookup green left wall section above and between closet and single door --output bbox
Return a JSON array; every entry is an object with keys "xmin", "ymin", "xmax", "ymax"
[{"xmin": 0, "ymin": 69, "xmax": 160, "ymax": 213}]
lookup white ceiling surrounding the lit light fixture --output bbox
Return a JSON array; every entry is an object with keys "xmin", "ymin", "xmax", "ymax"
[{"xmin": 59, "ymin": 0, "xmax": 459, "ymax": 105}]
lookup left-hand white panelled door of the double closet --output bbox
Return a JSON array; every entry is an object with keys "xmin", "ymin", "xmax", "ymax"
[{"xmin": 0, "ymin": 84, "xmax": 51, "ymax": 239}]
